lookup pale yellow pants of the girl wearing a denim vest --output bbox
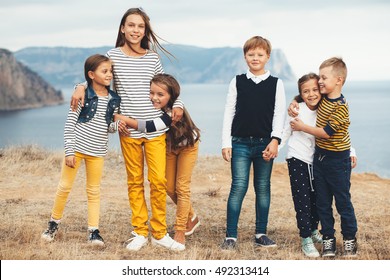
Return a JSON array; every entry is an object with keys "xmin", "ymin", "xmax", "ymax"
[{"xmin": 51, "ymin": 152, "xmax": 104, "ymax": 228}]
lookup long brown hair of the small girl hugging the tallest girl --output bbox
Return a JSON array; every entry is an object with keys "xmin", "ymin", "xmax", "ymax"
[{"xmin": 150, "ymin": 74, "xmax": 200, "ymax": 150}]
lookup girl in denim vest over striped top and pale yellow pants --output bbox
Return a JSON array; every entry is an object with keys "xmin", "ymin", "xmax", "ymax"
[{"xmin": 42, "ymin": 54, "xmax": 121, "ymax": 245}]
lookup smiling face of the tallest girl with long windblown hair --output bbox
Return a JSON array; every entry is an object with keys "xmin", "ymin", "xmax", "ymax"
[{"xmin": 121, "ymin": 14, "xmax": 146, "ymax": 47}]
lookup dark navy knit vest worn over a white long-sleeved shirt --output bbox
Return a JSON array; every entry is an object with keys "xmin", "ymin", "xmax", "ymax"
[{"xmin": 232, "ymin": 74, "xmax": 278, "ymax": 138}]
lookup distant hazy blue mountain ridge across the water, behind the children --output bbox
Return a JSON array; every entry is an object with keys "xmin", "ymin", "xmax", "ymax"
[{"xmin": 15, "ymin": 44, "xmax": 295, "ymax": 88}]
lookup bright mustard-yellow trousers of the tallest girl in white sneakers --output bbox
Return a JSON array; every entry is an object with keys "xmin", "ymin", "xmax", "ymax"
[{"xmin": 120, "ymin": 134, "xmax": 167, "ymax": 239}]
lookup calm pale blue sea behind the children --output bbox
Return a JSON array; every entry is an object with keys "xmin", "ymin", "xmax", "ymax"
[{"xmin": 0, "ymin": 80, "xmax": 390, "ymax": 178}]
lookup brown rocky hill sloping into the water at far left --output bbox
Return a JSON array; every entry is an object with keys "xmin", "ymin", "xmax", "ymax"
[{"xmin": 0, "ymin": 49, "xmax": 63, "ymax": 111}]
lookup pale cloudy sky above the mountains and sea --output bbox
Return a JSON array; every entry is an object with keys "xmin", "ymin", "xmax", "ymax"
[{"xmin": 0, "ymin": 0, "xmax": 390, "ymax": 80}]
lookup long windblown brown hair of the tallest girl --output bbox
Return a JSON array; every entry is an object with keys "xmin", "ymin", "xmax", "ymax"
[{"xmin": 115, "ymin": 8, "xmax": 174, "ymax": 57}]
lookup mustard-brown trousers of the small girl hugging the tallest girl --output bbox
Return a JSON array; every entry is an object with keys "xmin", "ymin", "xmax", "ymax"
[{"xmin": 166, "ymin": 141, "xmax": 199, "ymax": 231}]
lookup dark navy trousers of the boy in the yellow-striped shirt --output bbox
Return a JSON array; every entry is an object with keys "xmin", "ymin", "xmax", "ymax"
[{"xmin": 313, "ymin": 152, "xmax": 357, "ymax": 239}]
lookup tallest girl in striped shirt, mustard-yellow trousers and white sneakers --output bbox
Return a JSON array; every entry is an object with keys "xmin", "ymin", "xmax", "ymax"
[{"xmin": 72, "ymin": 8, "xmax": 184, "ymax": 251}]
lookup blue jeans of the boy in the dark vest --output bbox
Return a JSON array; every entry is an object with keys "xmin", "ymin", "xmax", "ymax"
[{"xmin": 226, "ymin": 137, "xmax": 273, "ymax": 238}]
